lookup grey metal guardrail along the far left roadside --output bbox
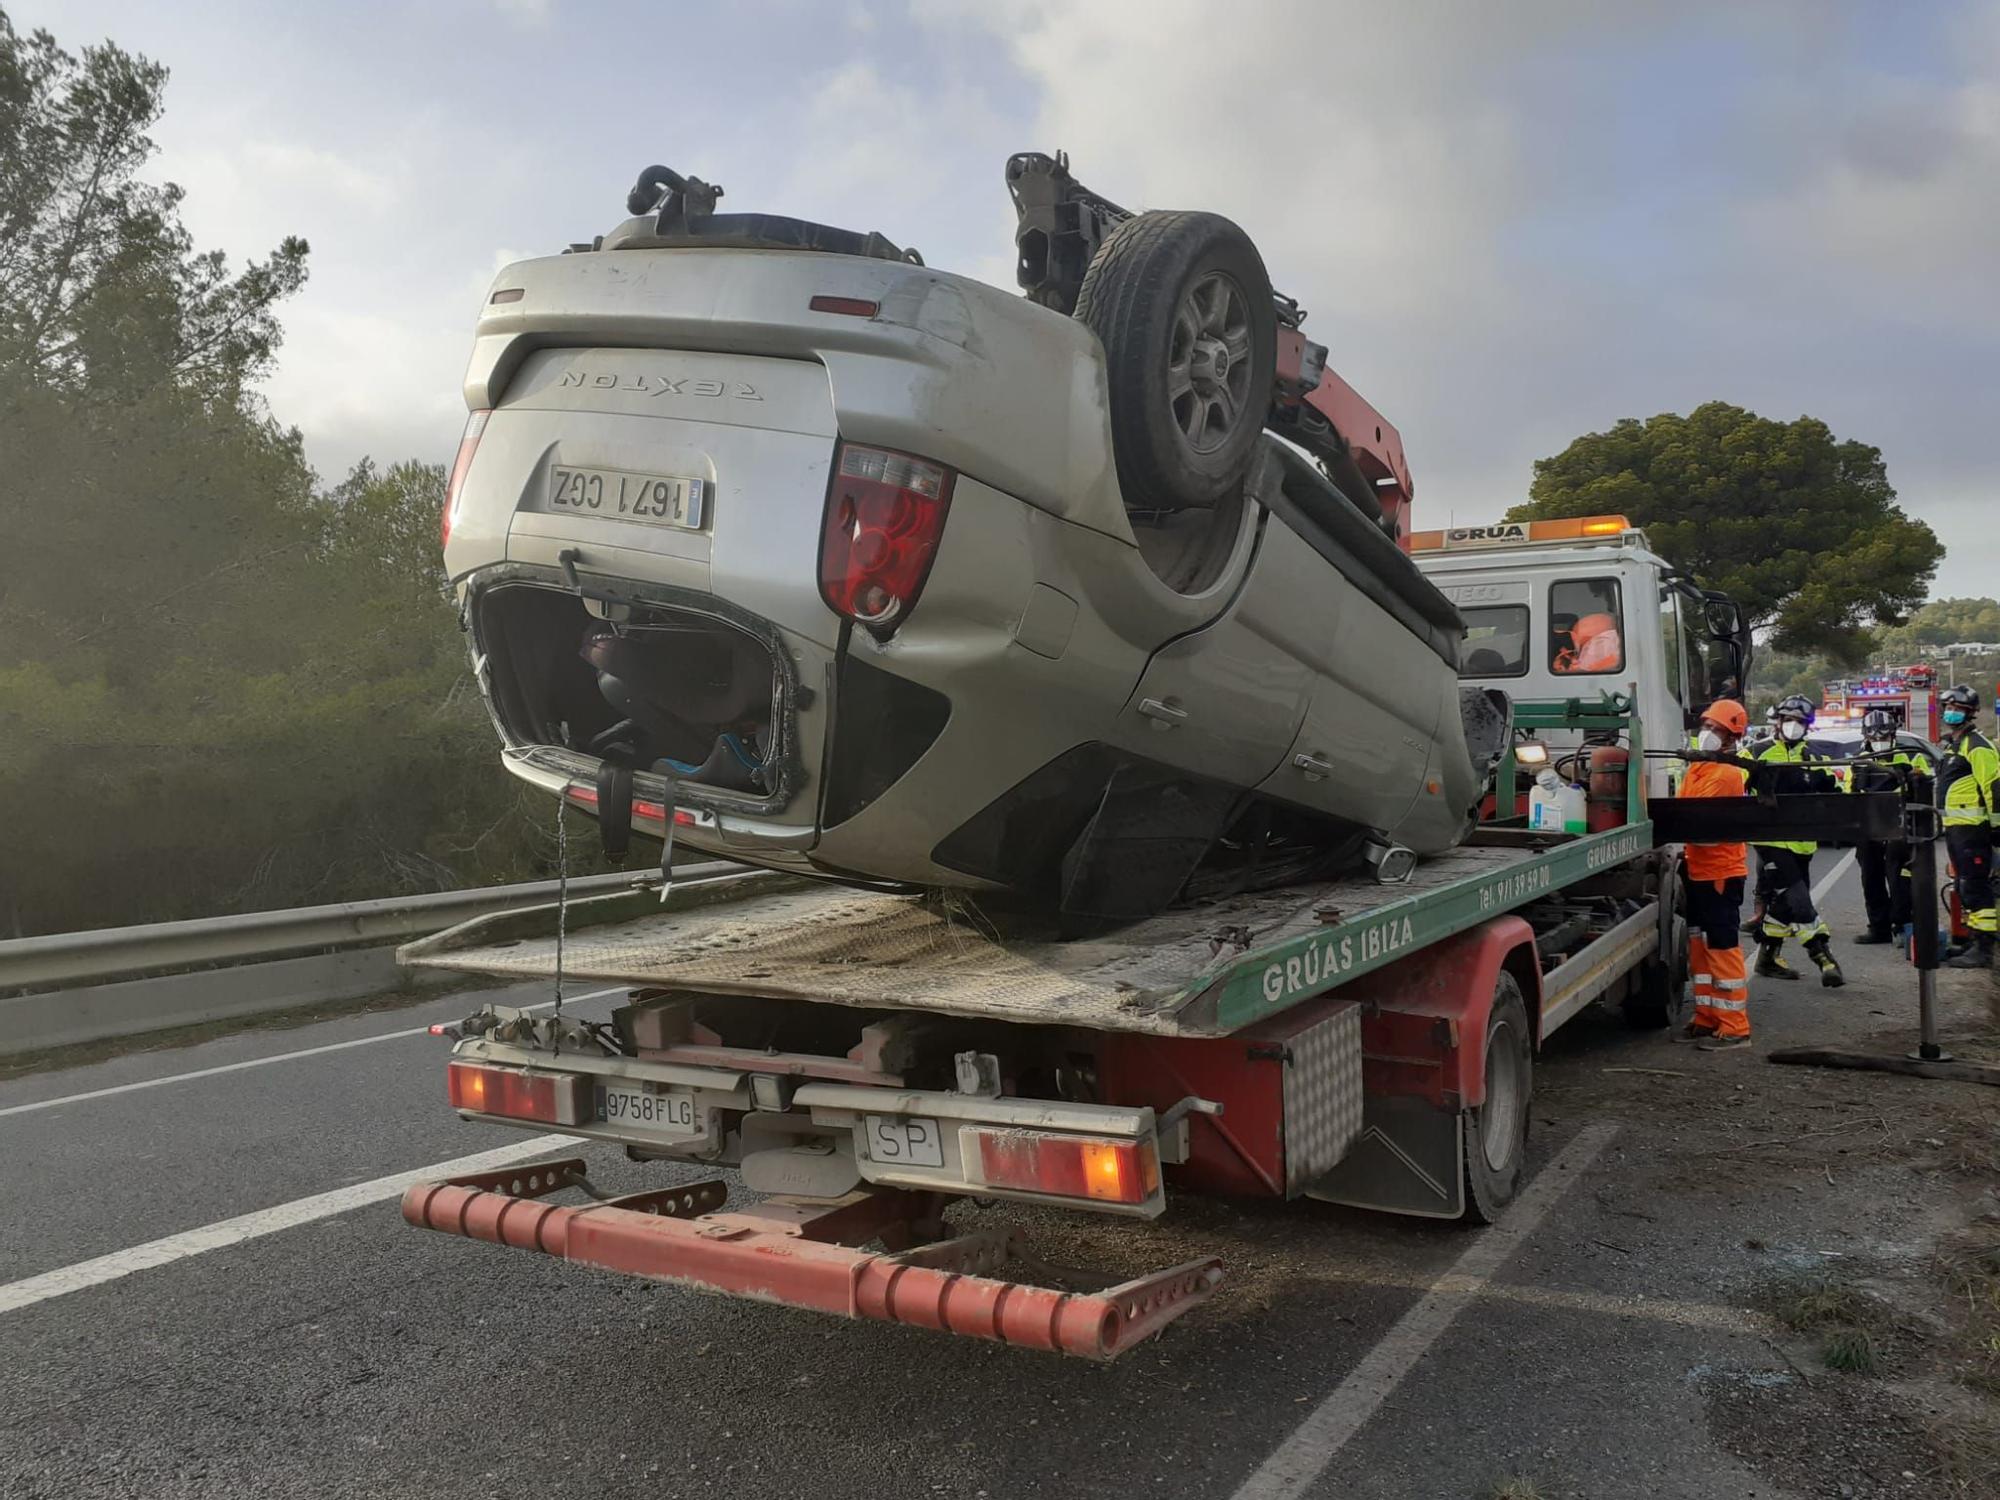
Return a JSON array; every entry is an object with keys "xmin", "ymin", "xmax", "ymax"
[{"xmin": 0, "ymin": 862, "xmax": 752, "ymax": 994}]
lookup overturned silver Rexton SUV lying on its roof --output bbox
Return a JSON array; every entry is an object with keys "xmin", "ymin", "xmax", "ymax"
[{"xmin": 444, "ymin": 154, "xmax": 1504, "ymax": 930}]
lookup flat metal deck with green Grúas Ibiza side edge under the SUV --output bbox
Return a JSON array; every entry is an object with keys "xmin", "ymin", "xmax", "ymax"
[{"xmin": 400, "ymin": 824, "xmax": 1652, "ymax": 1036}]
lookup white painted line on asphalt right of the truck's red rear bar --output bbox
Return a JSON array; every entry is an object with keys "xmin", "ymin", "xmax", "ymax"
[{"xmin": 1234, "ymin": 1124, "xmax": 1618, "ymax": 1500}]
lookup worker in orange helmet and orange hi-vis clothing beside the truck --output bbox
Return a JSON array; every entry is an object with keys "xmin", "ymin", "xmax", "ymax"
[{"xmin": 1680, "ymin": 698, "xmax": 1750, "ymax": 1052}]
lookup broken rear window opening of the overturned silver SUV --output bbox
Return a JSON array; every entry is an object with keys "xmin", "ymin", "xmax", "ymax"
[{"xmin": 480, "ymin": 584, "xmax": 778, "ymax": 796}]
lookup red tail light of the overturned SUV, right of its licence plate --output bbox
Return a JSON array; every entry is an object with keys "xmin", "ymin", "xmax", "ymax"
[{"xmin": 820, "ymin": 442, "xmax": 956, "ymax": 636}]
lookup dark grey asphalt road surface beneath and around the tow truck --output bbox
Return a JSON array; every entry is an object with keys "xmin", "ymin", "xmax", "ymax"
[{"xmin": 0, "ymin": 868, "xmax": 1976, "ymax": 1500}]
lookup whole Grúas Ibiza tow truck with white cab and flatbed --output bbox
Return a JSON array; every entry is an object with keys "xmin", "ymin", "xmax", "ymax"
[{"xmin": 402, "ymin": 156, "xmax": 1768, "ymax": 1360}]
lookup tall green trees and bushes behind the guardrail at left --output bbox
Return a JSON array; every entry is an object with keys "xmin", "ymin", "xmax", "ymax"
[{"xmin": 0, "ymin": 12, "xmax": 572, "ymax": 936}]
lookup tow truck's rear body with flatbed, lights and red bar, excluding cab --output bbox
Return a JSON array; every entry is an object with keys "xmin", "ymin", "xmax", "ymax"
[{"xmin": 402, "ymin": 698, "xmax": 1686, "ymax": 1360}]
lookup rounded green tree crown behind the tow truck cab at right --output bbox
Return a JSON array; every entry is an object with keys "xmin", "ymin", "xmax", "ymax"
[{"xmin": 1508, "ymin": 402, "xmax": 1944, "ymax": 662}]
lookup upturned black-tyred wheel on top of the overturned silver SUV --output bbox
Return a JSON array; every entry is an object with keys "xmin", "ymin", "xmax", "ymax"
[{"xmin": 1076, "ymin": 212, "xmax": 1278, "ymax": 510}]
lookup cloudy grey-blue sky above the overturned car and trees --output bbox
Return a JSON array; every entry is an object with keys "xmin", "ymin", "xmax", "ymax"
[{"xmin": 27, "ymin": 0, "xmax": 2000, "ymax": 594}]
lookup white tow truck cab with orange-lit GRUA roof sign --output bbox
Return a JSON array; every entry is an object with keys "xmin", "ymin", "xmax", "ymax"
[{"xmin": 1410, "ymin": 516, "xmax": 1750, "ymax": 796}]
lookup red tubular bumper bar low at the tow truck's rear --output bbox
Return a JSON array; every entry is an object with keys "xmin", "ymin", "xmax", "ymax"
[{"xmin": 402, "ymin": 1158, "xmax": 1222, "ymax": 1360}]
